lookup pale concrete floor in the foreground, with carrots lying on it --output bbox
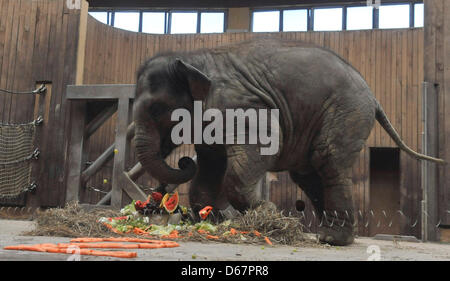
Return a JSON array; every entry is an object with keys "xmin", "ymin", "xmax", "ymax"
[{"xmin": 0, "ymin": 220, "xmax": 450, "ymax": 261}]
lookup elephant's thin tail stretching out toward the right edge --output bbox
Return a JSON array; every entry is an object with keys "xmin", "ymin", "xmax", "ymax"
[{"xmin": 375, "ymin": 102, "xmax": 447, "ymax": 164}]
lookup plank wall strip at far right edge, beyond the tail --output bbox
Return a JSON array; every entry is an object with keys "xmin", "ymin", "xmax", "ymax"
[{"xmin": 424, "ymin": 0, "xmax": 450, "ymax": 230}]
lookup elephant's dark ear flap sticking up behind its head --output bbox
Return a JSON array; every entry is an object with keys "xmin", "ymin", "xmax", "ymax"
[{"xmin": 175, "ymin": 59, "xmax": 211, "ymax": 100}]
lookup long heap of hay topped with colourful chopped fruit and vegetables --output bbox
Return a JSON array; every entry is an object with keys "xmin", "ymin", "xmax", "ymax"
[{"xmin": 28, "ymin": 197, "xmax": 311, "ymax": 247}]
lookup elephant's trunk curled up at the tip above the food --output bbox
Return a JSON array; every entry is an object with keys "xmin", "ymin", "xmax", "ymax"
[{"xmin": 135, "ymin": 120, "xmax": 196, "ymax": 184}]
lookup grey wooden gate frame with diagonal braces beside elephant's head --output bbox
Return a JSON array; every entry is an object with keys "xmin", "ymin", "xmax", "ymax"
[{"xmin": 66, "ymin": 85, "xmax": 146, "ymax": 208}]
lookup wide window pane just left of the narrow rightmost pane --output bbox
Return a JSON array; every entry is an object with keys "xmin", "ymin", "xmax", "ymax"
[{"xmin": 379, "ymin": 4, "xmax": 409, "ymax": 28}]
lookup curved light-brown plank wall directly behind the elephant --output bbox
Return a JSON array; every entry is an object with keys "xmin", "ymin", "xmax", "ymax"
[{"xmin": 83, "ymin": 17, "xmax": 423, "ymax": 236}]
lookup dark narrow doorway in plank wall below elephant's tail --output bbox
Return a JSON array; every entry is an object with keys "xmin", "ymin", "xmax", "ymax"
[{"xmin": 367, "ymin": 147, "xmax": 400, "ymax": 236}]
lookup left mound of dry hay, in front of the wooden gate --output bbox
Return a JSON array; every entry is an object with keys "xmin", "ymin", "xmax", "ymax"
[{"xmin": 25, "ymin": 202, "xmax": 119, "ymax": 237}]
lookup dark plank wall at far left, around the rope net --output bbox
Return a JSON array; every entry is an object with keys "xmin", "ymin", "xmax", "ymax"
[{"xmin": 0, "ymin": 0, "xmax": 79, "ymax": 206}]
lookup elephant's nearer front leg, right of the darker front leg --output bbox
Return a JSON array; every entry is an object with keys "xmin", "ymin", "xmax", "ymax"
[{"xmin": 222, "ymin": 145, "xmax": 275, "ymax": 211}]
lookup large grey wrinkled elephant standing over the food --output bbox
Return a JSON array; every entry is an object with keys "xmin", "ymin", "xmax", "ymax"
[{"xmin": 133, "ymin": 38, "xmax": 444, "ymax": 245}]
